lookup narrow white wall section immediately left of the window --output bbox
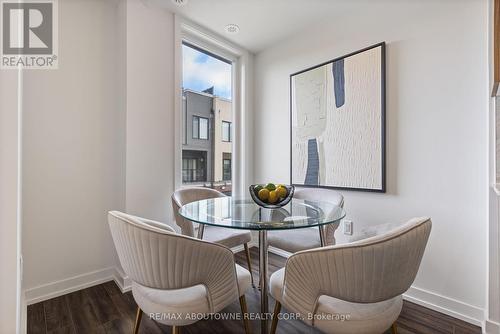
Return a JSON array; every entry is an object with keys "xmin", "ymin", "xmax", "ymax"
[{"xmin": 126, "ymin": 0, "xmax": 174, "ymax": 227}]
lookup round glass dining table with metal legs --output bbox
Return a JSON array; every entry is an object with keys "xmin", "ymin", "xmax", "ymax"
[{"xmin": 179, "ymin": 197, "xmax": 345, "ymax": 334}]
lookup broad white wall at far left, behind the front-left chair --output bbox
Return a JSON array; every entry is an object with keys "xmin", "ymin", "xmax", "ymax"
[{"xmin": 23, "ymin": 0, "xmax": 125, "ymax": 298}]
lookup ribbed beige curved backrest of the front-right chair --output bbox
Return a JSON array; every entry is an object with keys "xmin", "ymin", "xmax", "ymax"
[{"xmin": 283, "ymin": 218, "xmax": 432, "ymax": 314}]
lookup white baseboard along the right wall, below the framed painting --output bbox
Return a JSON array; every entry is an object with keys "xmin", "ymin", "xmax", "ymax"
[{"xmin": 269, "ymin": 247, "xmax": 486, "ymax": 328}]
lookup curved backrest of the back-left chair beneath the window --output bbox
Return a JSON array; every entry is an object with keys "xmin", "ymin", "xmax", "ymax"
[{"xmin": 172, "ymin": 187, "xmax": 226, "ymax": 237}]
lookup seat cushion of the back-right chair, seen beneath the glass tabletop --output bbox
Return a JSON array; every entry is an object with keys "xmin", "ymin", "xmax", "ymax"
[{"xmin": 267, "ymin": 227, "xmax": 321, "ymax": 253}]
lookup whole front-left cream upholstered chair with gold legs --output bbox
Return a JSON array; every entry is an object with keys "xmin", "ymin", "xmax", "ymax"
[{"xmin": 108, "ymin": 211, "xmax": 250, "ymax": 334}]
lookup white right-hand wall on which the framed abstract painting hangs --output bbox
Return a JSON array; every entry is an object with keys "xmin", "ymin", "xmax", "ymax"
[{"xmin": 254, "ymin": 1, "xmax": 488, "ymax": 323}]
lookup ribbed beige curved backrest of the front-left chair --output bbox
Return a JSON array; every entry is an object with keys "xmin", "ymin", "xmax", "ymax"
[{"xmin": 108, "ymin": 211, "xmax": 239, "ymax": 311}]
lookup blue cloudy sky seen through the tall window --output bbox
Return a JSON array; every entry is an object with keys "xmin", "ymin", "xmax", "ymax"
[{"xmin": 182, "ymin": 45, "xmax": 231, "ymax": 100}]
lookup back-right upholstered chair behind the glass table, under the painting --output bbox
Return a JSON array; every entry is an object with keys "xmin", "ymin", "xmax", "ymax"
[{"xmin": 267, "ymin": 187, "xmax": 344, "ymax": 253}]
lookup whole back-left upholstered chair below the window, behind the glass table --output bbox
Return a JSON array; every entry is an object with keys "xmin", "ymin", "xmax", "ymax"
[{"xmin": 172, "ymin": 187, "xmax": 255, "ymax": 287}]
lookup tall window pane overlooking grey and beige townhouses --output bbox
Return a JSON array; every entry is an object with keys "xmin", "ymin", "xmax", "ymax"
[{"xmin": 181, "ymin": 41, "xmax": 233, "ymax": 190}]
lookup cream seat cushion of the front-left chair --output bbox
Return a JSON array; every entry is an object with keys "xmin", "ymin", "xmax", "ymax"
[{"xmin": 132, "ymin": 265, "xmax": 251, "ymax": 326}]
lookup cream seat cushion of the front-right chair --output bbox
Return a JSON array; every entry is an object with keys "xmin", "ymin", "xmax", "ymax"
[{"xmin": 270, "ymin": 268, "xmax": 403, "ymax": 334}]
